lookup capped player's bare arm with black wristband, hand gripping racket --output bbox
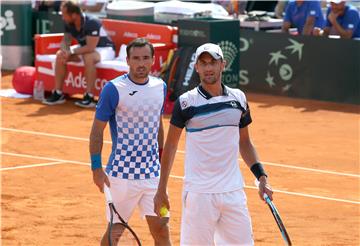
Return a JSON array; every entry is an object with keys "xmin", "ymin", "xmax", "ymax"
[{"xmin": 239, "ymin": 127, "xmax": 273, "ymax": 200}]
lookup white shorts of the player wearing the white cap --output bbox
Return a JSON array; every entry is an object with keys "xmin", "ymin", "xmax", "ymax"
[{"xmin": 180, "ymin": 189, "xmax": 254, "ymax": 245}]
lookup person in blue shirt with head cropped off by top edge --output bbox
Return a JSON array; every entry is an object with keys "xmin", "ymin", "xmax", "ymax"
[{"xmin": 282, "ymin": 0, "xmax": 324, "ymax": 35}]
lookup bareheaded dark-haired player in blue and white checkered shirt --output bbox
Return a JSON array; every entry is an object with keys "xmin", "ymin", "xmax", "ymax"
[{"xmin": 90, "ymin": 38, "xmax": 170, "ymax": 245}]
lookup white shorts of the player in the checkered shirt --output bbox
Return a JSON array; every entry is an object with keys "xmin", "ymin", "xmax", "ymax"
[{"xmin": 106, "ymin": 177, "xmax": 159, "ymax": 223}]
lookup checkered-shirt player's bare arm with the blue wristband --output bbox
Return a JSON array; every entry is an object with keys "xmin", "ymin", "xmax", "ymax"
[{"xmin": 89, "ymin": 119, "xmax": 110, "ymax": 192}]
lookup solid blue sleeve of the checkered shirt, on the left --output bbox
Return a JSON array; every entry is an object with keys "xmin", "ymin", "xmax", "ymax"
[{"xmin": 95, "ymin": 82, "xmax": 119, "ymax": 121}]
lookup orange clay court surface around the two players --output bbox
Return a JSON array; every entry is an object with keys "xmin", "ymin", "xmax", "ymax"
[{"xmin": 1, "ymin": 72, "xmax": 360, "ymax": 246}]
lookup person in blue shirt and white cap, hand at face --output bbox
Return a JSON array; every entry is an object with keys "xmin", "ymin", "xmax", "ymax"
[{"xmin": 322, "ymin": 0, "xmax": 360, "ymax": 39}]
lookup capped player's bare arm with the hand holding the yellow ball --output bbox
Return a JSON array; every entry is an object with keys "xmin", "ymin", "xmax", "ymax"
[{"xmin": 154, "ymin": 124, "xmax": 182, "ymax": 216}]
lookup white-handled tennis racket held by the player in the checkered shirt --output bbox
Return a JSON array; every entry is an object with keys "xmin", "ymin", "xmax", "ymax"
[{"xmin": 104, "ymin": 184, "xmax": 141, "ymax": 246}]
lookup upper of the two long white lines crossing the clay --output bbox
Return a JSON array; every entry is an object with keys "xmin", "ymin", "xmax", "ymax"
[{"xmin": 0, "ymin": 127, "xmax": 360, "ymax": 178}]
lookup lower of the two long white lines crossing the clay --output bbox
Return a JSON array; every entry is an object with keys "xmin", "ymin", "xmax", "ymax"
[{"xmin": 0, "ymin": 151, "xmax": 360, "ymax": 204}]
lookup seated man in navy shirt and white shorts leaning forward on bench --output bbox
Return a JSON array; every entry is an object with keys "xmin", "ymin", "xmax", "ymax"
[{"xmin": 43, "ymin": 1, "xmax": 115, "ymax": 108}]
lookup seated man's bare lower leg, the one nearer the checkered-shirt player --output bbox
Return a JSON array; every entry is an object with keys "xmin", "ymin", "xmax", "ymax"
[{"xmin": 83, "ymin": 51, "xmax": 100, "ymax": 93}]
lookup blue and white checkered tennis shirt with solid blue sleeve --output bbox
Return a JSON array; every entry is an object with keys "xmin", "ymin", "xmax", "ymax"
[{"xmin": 96, "ymin": 74, "xmax": 166, "ymax": 179}]
